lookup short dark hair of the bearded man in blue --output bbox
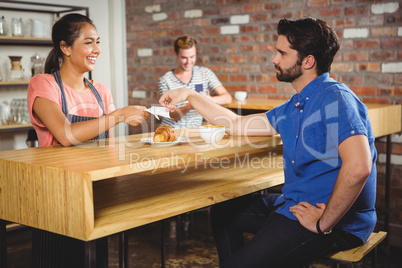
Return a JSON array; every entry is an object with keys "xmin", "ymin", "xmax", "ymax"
[{"xmin": 278, "ymin": 18, "xmax": 340, "ymax": 75}]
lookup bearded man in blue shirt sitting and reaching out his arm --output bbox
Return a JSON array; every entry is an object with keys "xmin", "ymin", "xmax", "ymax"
[{"xmin": 160, "ymin": 18, "xmax": 377, "ymax": 268}]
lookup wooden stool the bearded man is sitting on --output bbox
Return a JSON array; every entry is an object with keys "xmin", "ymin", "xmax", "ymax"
[{"xmin": 327, "ymin": 232, "xmax": 387, "ymax": 267}]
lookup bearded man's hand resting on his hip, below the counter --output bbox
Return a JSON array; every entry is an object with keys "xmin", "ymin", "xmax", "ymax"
[{"xmin": 289, "ymin": 202, "xmax": 326, "ymax": 234}]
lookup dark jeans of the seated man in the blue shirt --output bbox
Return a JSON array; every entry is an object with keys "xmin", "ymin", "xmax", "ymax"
[{"xmin": 211, "ymin": 194, "xmax": 362, "ymax": 268}]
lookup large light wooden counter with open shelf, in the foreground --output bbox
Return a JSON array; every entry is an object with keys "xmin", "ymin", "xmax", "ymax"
[{"xmin": 0, "ymin": 129, "xmax": 283, "ymax": 267}]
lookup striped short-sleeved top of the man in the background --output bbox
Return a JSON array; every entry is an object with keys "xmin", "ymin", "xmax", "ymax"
[{"xmin": 159, "ymin": 66, "xmax": 222, "ymax": 129}]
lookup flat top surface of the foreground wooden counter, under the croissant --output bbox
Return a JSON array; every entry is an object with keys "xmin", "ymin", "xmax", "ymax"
[{"xmin": 0, "ymin": 128, "xmax": 281, "ymax": 181}]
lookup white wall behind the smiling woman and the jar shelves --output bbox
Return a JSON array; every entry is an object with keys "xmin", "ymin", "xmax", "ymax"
[{"xmin": 0, "ymin": 0, "xmax": 128, "ymax": 150}]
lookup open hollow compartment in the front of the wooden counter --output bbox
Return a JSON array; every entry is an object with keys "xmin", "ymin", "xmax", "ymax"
[{"xmin": 89, "ymin": 151, "xmax": 284, "ymax": 239}]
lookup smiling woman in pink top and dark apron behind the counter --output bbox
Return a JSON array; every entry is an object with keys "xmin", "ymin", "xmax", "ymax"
[{"xmin": 27, "ymin": 14, "xmax": 149, "ymax": 267}]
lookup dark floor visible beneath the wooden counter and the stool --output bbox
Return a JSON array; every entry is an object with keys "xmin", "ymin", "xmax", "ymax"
[{"xmin": 8, "ymin": 210, "xmax": 402, "ymax": 268}]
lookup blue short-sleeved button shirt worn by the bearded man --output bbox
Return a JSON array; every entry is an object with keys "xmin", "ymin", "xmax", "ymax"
[{"xmin": 266, "ymin": 73, "xmax": 377, "ymax": 242}]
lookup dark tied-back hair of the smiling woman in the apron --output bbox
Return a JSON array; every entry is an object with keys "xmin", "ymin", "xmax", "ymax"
[{"xmin": 45, "ymin": 13, "xmax": 95, "ymax": 74}]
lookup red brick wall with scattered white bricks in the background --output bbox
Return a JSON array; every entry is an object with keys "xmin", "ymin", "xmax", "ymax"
[{"xmin": 126, "ymin": 0, "xmax": 402, "ymax": 242}]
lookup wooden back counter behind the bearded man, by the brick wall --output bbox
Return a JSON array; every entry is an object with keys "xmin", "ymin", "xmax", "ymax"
[{"xmin": 224, "ymin": 98, "xmax": 402, "ymax": 138}]
